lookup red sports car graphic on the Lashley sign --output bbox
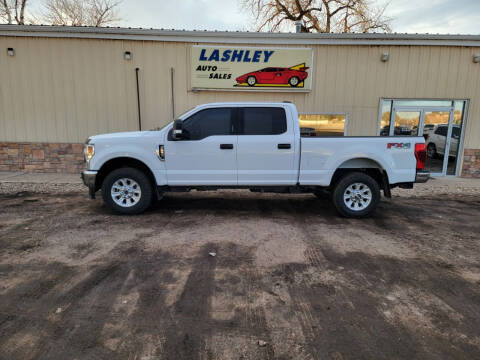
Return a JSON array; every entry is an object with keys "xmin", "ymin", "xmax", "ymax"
[{"xmin": 235, "ymin": 64, "xmax": 308, "ymax": 87}]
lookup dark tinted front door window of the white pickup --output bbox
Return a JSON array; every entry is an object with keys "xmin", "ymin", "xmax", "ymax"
[{"xmin": 183, "ymin": 108, "xmax": 232, "ymax": 140}]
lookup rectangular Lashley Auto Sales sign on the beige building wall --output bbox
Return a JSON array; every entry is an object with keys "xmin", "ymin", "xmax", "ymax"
[{"xmin": 191, "ymin": 45, "xmax": 313, "ymax": 91}]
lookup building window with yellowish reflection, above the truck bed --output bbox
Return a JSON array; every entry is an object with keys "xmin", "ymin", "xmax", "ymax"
[{"xmin": 298, "ymin": 114, "xmax": 348, "ymax": 137}]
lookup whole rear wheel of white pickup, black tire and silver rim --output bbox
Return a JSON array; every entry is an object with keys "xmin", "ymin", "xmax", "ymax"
[{"xmin": 332, "ymin": 172, "xmax": 380, "ymax": 218}]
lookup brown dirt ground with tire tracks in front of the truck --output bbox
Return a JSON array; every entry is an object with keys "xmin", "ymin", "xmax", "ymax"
[{"xmin": 0, "ymin": 190, "xmax": 480, "ymax": 360}]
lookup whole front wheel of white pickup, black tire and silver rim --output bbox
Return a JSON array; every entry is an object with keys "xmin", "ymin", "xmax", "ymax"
[{"xmin": 102, "ymin": 167, "xmax": 153, "ymax": 214}]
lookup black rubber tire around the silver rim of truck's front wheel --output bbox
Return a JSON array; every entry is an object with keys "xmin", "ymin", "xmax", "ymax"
[{"xmin": 102, "ymin": 167, "xmax": 154, "ymax": 215}]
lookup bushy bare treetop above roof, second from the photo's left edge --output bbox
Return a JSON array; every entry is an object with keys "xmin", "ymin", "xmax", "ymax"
[{"xmin": 41, "ymin": 0, "xmax": 121, "ymax": 26}]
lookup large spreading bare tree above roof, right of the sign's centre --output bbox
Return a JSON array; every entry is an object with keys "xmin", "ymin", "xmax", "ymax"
[{"xmin": 242, "ymin": 0, "xmax": 391, "ymax": 33}]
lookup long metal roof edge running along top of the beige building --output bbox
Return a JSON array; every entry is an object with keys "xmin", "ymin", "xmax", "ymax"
[{"xmin": 0, "ymin": 25, "xmax": 480, "ymax": 47}]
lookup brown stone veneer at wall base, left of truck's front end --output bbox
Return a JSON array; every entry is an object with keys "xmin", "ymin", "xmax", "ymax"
[{"xmin": 0, "ymin": 142, "xmax": 85, "ymax": 174}]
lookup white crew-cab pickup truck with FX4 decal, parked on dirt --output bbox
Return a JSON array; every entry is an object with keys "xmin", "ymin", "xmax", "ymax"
[{"xmin": 82, "ymin": 102, "xmax": 429, "ymax": 217}]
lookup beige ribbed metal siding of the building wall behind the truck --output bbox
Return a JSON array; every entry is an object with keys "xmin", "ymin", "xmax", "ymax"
[{"xmin": 0, "ymin": 37, "xmax": 480, "ymax": 148}]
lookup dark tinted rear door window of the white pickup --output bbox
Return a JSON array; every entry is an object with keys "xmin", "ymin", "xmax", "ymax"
[{"xmin": 239, "ymin": 107, "xmax": 287, "ymax": 135}]
